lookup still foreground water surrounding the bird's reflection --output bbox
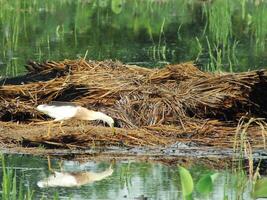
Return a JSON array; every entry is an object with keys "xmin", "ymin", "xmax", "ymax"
[{"xmin": 0, "ymin": 155, "xmax": 252, "ymax": 200}]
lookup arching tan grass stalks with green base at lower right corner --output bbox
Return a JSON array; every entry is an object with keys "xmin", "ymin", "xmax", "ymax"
[{"xmin": 232, "ymin": 117, "xmax": 267, "ymax": 199}]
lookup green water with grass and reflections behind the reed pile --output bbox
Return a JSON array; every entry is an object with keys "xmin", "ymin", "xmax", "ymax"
[{"xmin": 0, "ymin": 0, "xmax": 267, "ymax": 75}]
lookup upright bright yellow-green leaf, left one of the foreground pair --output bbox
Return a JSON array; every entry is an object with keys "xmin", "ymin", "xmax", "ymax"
[{"xmin": 179, "ymin": 166, "xmax": 194, "ymax": 198}]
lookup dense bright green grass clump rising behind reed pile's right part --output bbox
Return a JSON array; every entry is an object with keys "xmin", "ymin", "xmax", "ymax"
[{"xmin": 203, "ymin": 0, "xmax": 238, "ymax": 72}]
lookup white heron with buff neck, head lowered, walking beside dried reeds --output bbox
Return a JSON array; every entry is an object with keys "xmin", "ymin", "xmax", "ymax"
[{"xmin": 37, "ymin": 101, "xmax": 115, "ymax": 136}]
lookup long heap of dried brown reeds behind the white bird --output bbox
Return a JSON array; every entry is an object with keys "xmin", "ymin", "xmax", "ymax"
[{"xmin": 0, "ymin": 59, "xmax": 267, "ymax": 149}]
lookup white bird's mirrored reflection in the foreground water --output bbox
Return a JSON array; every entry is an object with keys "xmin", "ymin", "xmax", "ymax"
[{"xmin": 37, "ymin": 158, "xmax": 113, "ymax": 188}]
